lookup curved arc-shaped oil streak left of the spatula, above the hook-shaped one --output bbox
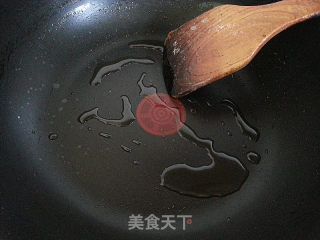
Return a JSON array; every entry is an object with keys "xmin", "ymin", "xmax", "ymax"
[{"xmin": 90, "ymin": 58, "xmax": 155, "ymax": 86}]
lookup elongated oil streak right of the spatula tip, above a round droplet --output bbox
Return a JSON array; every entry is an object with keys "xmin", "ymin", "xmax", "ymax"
[{"xmin": 222, "ymin": 99, "xmax": 259, "ymax": 142}]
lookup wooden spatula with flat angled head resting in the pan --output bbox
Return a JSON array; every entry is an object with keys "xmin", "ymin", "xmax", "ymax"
[{"xmin": 165, "ymin": 0, "xmax": 320, "ymax": 97}]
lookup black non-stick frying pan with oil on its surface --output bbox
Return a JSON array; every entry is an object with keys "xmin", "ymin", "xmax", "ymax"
[{"xmin": 0, "ymin": 0, "xmax": 320, "ymax": 240}]
